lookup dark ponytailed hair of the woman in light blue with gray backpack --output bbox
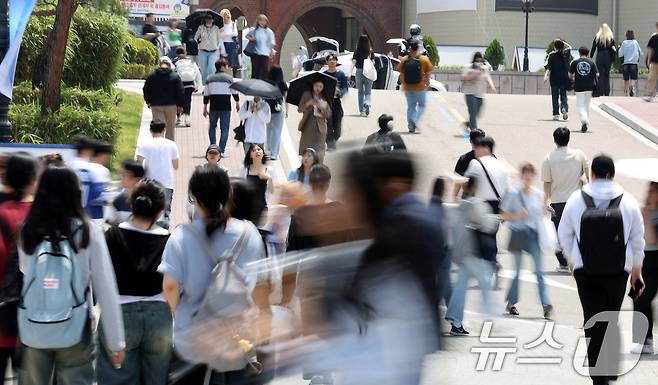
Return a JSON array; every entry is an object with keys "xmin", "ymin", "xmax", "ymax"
[{"xmin": 188, "ymin": 167, "xmax": 231, "ymax": 237}]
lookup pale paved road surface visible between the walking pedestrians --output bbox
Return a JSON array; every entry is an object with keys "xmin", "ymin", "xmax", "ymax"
[{"xmin": 275, "ymin": 91, "xmax": 658, "ymax": 385}]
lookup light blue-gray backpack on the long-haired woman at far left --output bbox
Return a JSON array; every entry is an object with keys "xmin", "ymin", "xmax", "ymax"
[{"xmin": 18, "ymin": 239, "xmax": 90, "ymax": 349}]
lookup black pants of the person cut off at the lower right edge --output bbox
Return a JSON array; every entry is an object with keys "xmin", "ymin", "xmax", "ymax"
[{"xmin": 633, "ymin": 251, "xmax": 658, "ymax": 344}]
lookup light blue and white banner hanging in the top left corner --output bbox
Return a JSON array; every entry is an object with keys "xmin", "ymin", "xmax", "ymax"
[{"xmin": 0, "ymin": 0, "xmax": 37, "ymax": 99}]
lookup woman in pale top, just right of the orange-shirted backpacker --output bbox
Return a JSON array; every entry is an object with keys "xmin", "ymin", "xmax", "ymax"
[{"xmin": 462, "ymin": 52, "xmax": 496, "ymax": 130}]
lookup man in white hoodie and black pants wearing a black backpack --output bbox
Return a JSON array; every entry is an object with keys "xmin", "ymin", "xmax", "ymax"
[{"xmin": 558, "ymin": 155, "xmax": 645, "ymax": 385}]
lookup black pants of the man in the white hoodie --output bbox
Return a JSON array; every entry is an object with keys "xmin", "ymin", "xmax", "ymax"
[{"xmin": 573, "ymin": 269, "xmax": 628, "ymax": 385}]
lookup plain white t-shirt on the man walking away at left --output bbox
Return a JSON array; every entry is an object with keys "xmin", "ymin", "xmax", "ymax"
[{"xmin": 137, "ymin": 137, "xmax": 178, "ymax": 189}]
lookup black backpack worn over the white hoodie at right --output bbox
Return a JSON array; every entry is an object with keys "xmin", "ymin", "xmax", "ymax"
[{"xmin": 578, "ymin": 192, "xmax": 626, "ymax": 275}]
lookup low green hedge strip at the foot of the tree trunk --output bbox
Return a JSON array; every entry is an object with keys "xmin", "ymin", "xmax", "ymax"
[{"xmin": 9, "ymin": 104, "xmax": 120, "ymax": 143}]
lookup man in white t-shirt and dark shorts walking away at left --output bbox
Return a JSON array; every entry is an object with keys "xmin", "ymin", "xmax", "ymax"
[{"xmin": 136, "ymin": 120, "xmax": 179, "ymax": 228}]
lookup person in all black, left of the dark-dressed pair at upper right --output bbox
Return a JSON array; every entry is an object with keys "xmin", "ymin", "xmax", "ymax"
[{"xmin": 544, "ymin": 39, "xmax": 571, "ymax": 120}]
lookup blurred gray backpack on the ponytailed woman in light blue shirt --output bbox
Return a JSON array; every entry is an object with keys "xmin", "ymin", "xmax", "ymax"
[{"xmin": 179, "ymin": 224, "xmax": 262, "ymax": 372}]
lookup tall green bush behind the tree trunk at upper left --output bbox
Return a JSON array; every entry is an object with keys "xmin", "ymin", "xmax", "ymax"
[{"xmin": 16, "ymin": 7, "xmax": 126, "ymax": 89}]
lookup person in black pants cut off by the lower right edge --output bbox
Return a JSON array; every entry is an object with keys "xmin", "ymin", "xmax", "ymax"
[{"xmin": 633, "ymin": 182, "xmax": 658, "ymax": 354}]
